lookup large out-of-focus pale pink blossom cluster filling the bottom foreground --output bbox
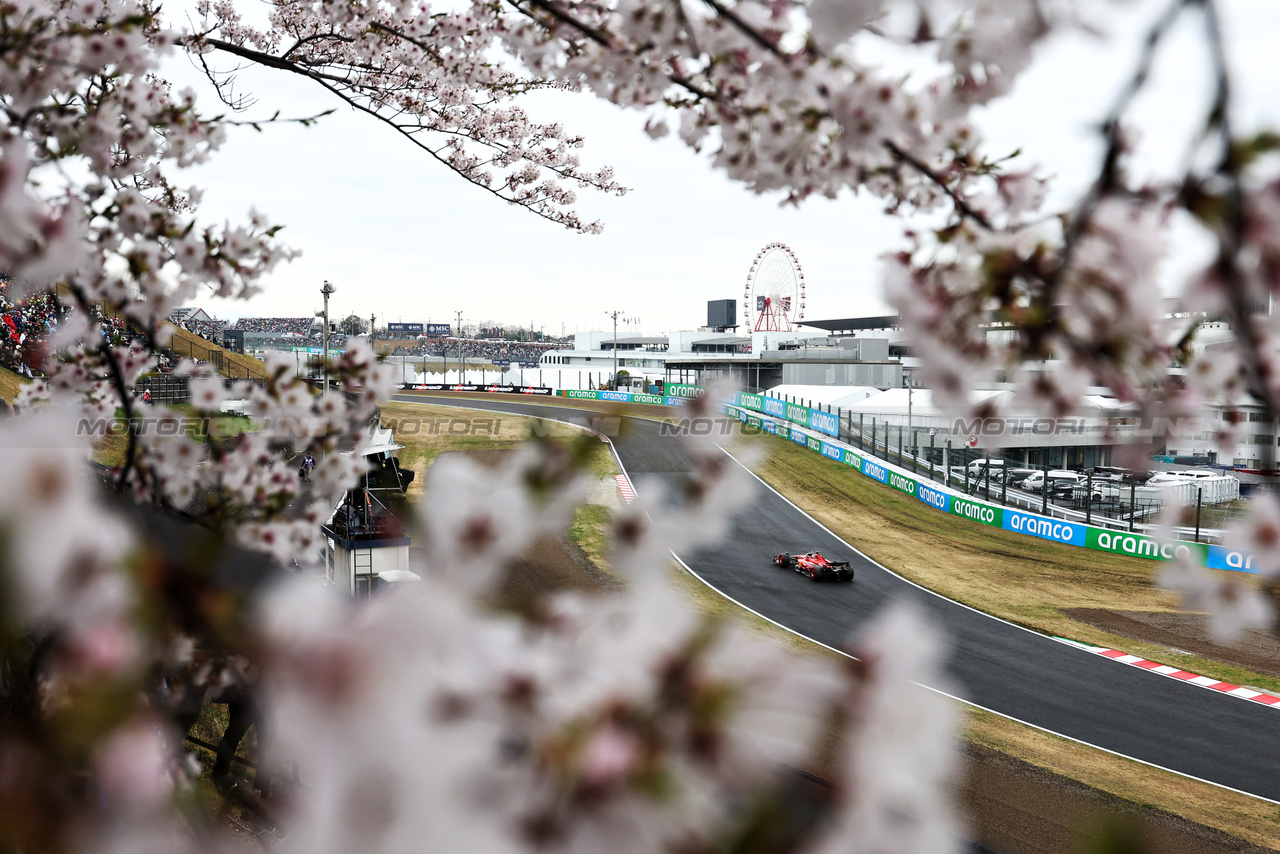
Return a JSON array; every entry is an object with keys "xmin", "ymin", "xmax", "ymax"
[{"xmin": 0, "ymin": 391, "xmax": 957, "ymax": 854}]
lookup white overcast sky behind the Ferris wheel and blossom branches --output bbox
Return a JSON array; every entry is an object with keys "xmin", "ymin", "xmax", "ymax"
[{"xmin": 166, "ymin": 0, "xmax": 1280, "ymax": 334}]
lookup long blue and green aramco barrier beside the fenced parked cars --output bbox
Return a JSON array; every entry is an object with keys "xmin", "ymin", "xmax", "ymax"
[{"xmin": 724, "ymin": 392, "xmax": 1258, "ymax": 572}]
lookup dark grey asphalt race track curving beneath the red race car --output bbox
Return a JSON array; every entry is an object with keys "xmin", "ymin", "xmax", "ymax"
[{"xmin": 394, "ymin": 396, "xmax": 1280, "ymax": 802}]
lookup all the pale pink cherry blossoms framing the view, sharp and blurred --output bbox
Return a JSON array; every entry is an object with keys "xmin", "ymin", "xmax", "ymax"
[{"xmin": 0, "ymin": 0, "xmax": 1280, "ymax": 854}]
